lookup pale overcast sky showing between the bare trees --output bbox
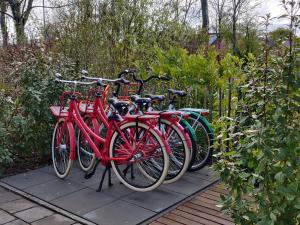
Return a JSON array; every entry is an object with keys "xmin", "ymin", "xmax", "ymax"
[{"xmin": 1, "ymin": 0, "xmax": 294, "ymax": 42}]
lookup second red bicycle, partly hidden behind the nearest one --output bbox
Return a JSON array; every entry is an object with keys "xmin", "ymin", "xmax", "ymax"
[{"xmin": 77, "ymin": 71, "xmax": 192, "ymax": 184}]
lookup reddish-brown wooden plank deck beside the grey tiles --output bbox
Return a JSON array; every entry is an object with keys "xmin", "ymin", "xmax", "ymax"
[{"xmin": 150, "ymin": 185, "xmax": 234, "ymax": 225}]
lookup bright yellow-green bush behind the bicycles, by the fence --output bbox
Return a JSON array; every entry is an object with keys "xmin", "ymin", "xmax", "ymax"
[{"xmin": 151, "ymin": 47, "xmax": 218, "ymax": 106}]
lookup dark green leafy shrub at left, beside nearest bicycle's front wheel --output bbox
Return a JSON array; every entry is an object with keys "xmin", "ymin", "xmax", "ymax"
[{"xmin": 0, "ymin": 49, "xmax": 75, "ymax": 166}]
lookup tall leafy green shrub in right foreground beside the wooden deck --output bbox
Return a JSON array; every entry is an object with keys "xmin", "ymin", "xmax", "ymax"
[{"xmin": 214, "ymin": 7, "xmax": 300, "ymax": 225}]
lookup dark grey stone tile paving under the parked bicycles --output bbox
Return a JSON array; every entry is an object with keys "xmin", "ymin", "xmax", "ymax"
[{"xmin": 0, "ymin": 163, "xmax": 218, "ymax": 225}]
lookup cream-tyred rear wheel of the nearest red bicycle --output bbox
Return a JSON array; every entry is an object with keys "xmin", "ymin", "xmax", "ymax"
[{"xmin": 109, "ymin": 122, "xmax": 169, "ymax": 192}]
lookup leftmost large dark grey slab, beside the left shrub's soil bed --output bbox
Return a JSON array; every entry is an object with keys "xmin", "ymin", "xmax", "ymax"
[{"xmin": 1, "ymin": 169, "xmax": 56, "ymax": 189}]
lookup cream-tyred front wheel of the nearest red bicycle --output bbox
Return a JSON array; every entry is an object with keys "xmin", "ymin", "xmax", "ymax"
[{"xmin": 52, "ymin": 118, "xmax": 75, "ymax": 179}]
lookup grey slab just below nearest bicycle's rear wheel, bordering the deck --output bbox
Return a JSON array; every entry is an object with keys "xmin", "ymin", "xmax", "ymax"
[{"xmin": 122, "ymin": 188, "xmax": 186, "ymax": 212}]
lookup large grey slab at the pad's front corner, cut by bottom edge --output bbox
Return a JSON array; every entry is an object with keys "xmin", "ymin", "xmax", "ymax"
[{"xmin": 84, "ymin": 200, "xmax": 155, "ymax": 225}]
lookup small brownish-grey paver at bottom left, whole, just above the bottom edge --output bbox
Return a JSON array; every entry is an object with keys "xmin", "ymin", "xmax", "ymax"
[{"xmin": 15, "ymin": 206, "xmax": 53, "ymax": 223}]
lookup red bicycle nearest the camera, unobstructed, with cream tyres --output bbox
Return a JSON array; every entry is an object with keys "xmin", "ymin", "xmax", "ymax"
[{"xmin": 50, "ymin": 74, "xmax": 170, "ymax": 191}]
